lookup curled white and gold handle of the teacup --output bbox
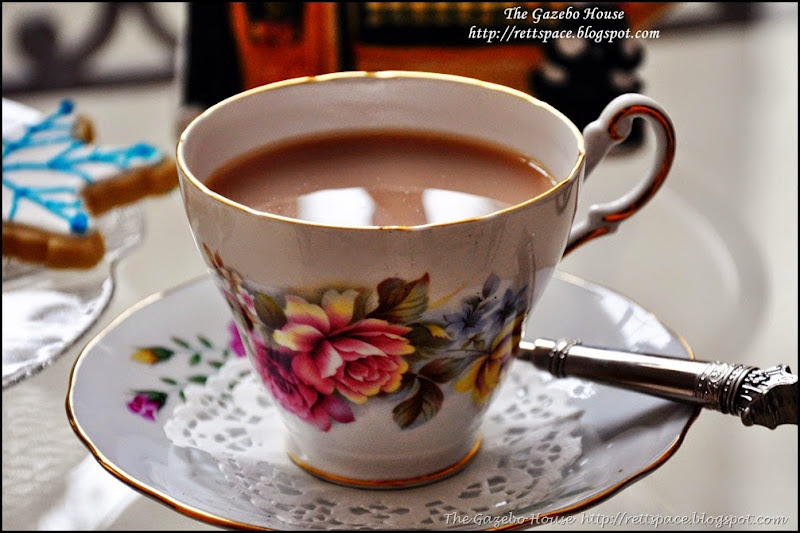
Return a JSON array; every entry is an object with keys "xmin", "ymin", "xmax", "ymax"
[{"xmin": 564, "ymin": 94, "xmax": 675, "ymax": 256}]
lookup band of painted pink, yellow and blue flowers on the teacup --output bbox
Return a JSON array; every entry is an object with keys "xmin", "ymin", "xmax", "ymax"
[{"xmin": 208, "ymin": 246, "xmax": 528, "ymax": 431}]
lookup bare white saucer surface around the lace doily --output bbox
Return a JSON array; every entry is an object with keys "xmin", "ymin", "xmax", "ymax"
[{"xmin": 67, "ymin": 275, "xmax": 698, "ymax": 529}]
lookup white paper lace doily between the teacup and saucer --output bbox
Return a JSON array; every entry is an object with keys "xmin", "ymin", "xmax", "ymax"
[{"xmin": 164, "ymin": 358, "xmax": 582, "ymax": 529}]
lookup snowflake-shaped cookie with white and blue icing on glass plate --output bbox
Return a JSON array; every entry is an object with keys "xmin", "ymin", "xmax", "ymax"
[{"xmin": 3, "ymin": 99, "xmax": 177, "ymax": 268}]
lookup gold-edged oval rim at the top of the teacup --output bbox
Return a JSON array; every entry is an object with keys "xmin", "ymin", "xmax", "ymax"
[{"xmin": 175, "ymin": 70, "xmax": 586, "ymax": 231}]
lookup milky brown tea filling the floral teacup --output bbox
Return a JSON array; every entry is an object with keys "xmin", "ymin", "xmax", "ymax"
[{"xmin": 205, "ymin": 131, "xmax": 554, "ymax": 226}]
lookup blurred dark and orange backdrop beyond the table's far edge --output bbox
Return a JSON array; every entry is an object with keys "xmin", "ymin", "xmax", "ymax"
[{"xmin": 2, "ymin": 2, "xmax": 792, "ymax": 133}]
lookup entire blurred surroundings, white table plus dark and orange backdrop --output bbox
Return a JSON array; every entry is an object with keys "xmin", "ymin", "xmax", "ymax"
[{"xmin": 2, "ymin": 2, "xmax": 800, "ymax": 530}]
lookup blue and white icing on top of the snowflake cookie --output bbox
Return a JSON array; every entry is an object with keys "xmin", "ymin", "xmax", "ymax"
[{"xmin": 3, "ymin": 100, "xmax": 163, "ymax": 235}]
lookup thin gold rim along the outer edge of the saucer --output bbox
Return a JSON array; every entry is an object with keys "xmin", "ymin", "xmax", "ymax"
[{"xmin": 66, "ymin": 272, "xmax": 702, "ymax": 531}]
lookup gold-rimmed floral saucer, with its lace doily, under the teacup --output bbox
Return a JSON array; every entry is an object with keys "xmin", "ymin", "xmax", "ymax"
[{"xmin": 67, "ymin": 274, "xmax": 699, "ymax": 530}]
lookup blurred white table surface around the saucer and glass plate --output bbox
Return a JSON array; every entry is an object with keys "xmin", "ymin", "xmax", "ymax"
[{"xmin": 2, "ymin": 6, "xmax": 800, "ymax": 530}]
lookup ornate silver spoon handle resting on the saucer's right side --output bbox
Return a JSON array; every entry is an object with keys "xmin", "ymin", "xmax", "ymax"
[{"xmin": 519, "ymin": 339, "xmax": 798, "ymax": 429}]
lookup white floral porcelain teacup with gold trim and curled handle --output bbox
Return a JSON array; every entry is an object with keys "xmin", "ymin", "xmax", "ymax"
[{"xmin": 177, "ymin": 72, "xmax": 675, "ymax": 488}]
